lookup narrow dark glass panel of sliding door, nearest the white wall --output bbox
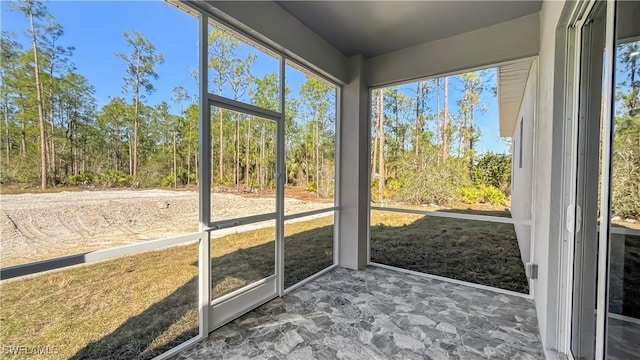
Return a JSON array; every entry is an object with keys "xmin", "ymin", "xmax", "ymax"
[{"xmin": 571, "ymin": 2, "xmax": 606, "ymax": 359}]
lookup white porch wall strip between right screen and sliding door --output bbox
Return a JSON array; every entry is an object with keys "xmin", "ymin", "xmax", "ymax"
[{"xmin": 532, "ymin": 1, "xmax": 564, "ymax": 350}]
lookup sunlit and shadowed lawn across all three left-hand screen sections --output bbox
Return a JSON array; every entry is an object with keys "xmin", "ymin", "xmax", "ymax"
[{"xmin": 0, "ymin": 216, "xmax": 333, "ymax": 359}]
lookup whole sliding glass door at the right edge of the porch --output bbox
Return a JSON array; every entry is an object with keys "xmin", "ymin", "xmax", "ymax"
[{"xmin": 571, "ymin": 1, "xmax": 640, "ymax": 359}]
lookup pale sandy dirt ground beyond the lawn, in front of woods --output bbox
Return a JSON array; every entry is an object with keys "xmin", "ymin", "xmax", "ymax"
[{"xmin": 0, "ymin": 190, "xmax": 331, "ymax": 267}]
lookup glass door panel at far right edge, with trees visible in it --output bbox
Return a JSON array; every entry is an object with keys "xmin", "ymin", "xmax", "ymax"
[{"xmin": 606, "ymin": 1, "xmax": 640, "ymax": 360}]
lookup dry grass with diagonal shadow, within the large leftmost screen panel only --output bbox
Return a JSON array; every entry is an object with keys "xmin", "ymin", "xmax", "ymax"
[{"xmin": 0, "ymin": 244, "xmax": 198, "ymax": 359}]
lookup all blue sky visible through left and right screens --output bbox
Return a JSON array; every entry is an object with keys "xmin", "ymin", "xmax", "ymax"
[{"xmin": 0, "ymin": 1, "xmax": 506, "ymax": 153}]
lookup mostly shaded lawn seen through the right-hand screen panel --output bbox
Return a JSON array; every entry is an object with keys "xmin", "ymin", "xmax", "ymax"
[{"xmin": 370, "ymin": 210, "xmax": 529, "ymax": 293}]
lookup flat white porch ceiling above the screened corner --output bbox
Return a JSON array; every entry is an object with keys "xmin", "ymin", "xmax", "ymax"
[{"xmin": 276, "ymin": 0, "xmax": 542, "ymax": 57}]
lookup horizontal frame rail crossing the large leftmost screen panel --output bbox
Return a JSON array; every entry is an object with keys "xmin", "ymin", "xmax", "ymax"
[{"xmin": 0, "ymin": 232, "xmax": 202, "ymax": 280}]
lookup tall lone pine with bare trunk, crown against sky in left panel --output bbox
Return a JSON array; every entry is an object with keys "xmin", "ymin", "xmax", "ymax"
[{"xmin": 115, "ymin": 30, "xmax": 164, "ymax": 179}]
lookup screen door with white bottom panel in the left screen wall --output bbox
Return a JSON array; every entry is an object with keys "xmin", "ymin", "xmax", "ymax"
[{"xmin": 209, "ymin": 101, "xmax": 278, "ymax": 330}]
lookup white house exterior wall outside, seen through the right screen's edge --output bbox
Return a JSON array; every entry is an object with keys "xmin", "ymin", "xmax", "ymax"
[{"xmin": 511, "ymin": 61, "xmax": 537, "ymax": 264}]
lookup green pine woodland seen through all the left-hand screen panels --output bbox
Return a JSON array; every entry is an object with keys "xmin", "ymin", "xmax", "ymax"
[{"xmin": 0, "ymin": 10, "xmax": 337, "ymax": 197}]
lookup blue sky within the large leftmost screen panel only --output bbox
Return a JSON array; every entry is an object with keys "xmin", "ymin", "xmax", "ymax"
[{"xmin": 1, "ymin": 1, "xmax": 198, "ymax": 111}]
